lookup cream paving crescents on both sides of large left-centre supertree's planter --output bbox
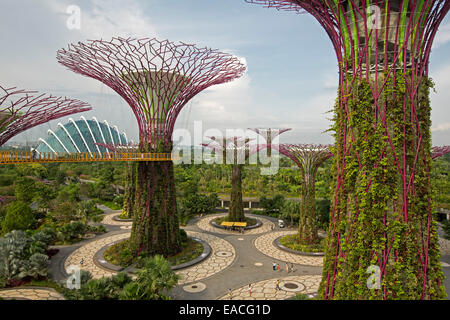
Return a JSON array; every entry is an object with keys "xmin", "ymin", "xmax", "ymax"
[{"xmin": 64, "ymin": 231, "xmax": 236, "ymax": 284}]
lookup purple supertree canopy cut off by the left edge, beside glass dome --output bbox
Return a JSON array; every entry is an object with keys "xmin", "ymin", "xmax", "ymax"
[{"xmin": 0, "ymin": 86, "xmax": 91, "ymax": 146}]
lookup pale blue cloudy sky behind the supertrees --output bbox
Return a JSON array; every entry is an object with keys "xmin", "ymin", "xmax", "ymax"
[{"xmin": 0, "ymin": 0, "xmax": 450, "ymax": 145}]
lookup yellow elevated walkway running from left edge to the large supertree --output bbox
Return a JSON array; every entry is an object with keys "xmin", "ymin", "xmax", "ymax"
[{"xmin": 0, "ymin": 151, "xmax": 172, "ymax": 164}]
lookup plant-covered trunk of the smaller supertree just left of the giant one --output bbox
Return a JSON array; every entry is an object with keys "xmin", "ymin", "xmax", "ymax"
[{"xmin": 298, "ymin": 175, "xmax": 319, "ymax": 245}]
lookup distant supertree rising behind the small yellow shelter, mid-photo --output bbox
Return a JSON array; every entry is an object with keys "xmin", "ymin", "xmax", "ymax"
[{"xmin": 202, "ymin": 136, "xmax": 267, "ymax": 222}]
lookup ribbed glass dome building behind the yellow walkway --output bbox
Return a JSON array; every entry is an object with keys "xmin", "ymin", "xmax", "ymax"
[{"xmin": 36, "ymin": 116, "xmax": 129, "ymax": 154}]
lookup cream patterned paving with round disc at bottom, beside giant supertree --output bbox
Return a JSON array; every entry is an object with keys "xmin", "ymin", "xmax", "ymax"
[{"xmin": 219, "ymin": 275, "xmax": 322, "ymax": 300}]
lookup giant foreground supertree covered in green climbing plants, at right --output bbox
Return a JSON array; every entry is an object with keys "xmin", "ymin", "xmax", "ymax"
[{"xmin": 246, "ymin": 0, "xmax": 450, "ymax": 299}]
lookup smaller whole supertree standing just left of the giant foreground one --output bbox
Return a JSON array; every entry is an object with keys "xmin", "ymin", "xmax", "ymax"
[{"xmin": 273, "ymin": 144, "xmax": 333, "ymax": 245}]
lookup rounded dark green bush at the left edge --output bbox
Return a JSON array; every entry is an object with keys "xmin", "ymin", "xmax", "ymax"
[{"xmin": 2, "ymin": 201, "xmax": 36, "ymax": 234}]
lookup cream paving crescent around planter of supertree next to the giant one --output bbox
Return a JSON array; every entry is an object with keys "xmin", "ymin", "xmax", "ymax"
[{"xmin": 254, "ymin": 231, "xmax": 323, "ymax": 268}]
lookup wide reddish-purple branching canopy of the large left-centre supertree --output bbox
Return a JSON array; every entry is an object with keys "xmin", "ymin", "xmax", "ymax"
[{"xmin": 57, "ymin": 38, "xmax": 246, "ymax": 147}]
